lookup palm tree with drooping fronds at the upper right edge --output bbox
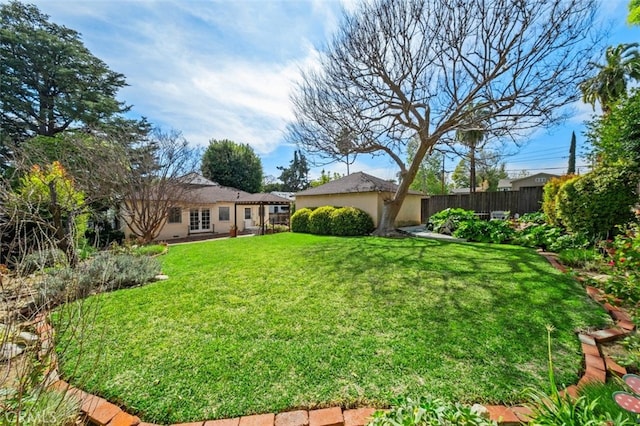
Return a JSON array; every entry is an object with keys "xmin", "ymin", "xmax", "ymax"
[{"xmin": 580, "ymin": 43, "xmax": 640, "ymax": 115}]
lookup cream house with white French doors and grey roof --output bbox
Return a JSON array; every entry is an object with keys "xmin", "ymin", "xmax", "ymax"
[{"xmin": 124, "ymin": 174, "xmax": 287, "ymax": 241}]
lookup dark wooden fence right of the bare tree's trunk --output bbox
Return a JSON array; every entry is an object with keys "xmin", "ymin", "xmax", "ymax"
[{"xmin": 421, "ymin": 186, "xmax": 542, "ymax": 223}]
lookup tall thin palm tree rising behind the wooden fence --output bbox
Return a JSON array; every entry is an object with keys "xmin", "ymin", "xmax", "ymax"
[{"xmin": 456, "ymin": 104, "xmax": 490, "ymax": 193}]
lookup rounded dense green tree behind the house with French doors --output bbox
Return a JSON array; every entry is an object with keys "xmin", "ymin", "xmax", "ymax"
[{"xmin": 202, "ymin": 139, "xmax": 262, "ymax": 193}]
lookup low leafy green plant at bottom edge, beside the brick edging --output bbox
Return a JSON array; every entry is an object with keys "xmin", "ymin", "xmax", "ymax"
[{"xmin": 369, "ymin": 398, "xmax": 496, "ymax": 426}]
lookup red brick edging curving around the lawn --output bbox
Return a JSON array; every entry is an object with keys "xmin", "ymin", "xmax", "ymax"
[{"xmin": 35, "ymin": 252, "xmax": 635, "ymax": 426}]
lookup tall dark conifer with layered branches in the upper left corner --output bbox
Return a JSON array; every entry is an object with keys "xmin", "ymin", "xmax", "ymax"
[{"xmin": 0, "ymin": 1, "xmax": 126, "ymax": 140}]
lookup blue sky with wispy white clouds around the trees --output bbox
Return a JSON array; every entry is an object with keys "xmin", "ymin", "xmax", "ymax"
[{"xmin": 12, "ymin": 0, "xmax": 640, "ymax": 183}]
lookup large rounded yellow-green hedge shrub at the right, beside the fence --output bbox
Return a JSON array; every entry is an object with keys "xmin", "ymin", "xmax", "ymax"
[{"xmin": 556, "ymin": 167, "xmax": 638, "ymax": 239}]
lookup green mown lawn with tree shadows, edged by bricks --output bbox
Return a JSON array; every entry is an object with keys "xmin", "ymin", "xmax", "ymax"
[{"xmin": 60, "ymin": 233, "xmax": 606, "ymax": 423}]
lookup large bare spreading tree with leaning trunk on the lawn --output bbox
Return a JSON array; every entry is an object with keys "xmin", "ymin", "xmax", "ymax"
[{"xmin": 289, "ymin": 0, "xmax": 597, "ymax": 235}]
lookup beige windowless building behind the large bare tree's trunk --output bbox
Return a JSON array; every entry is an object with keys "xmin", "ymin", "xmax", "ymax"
[{"xmin": 296, "ymin": 172, "xmax": 424, "ymax": 226}]
